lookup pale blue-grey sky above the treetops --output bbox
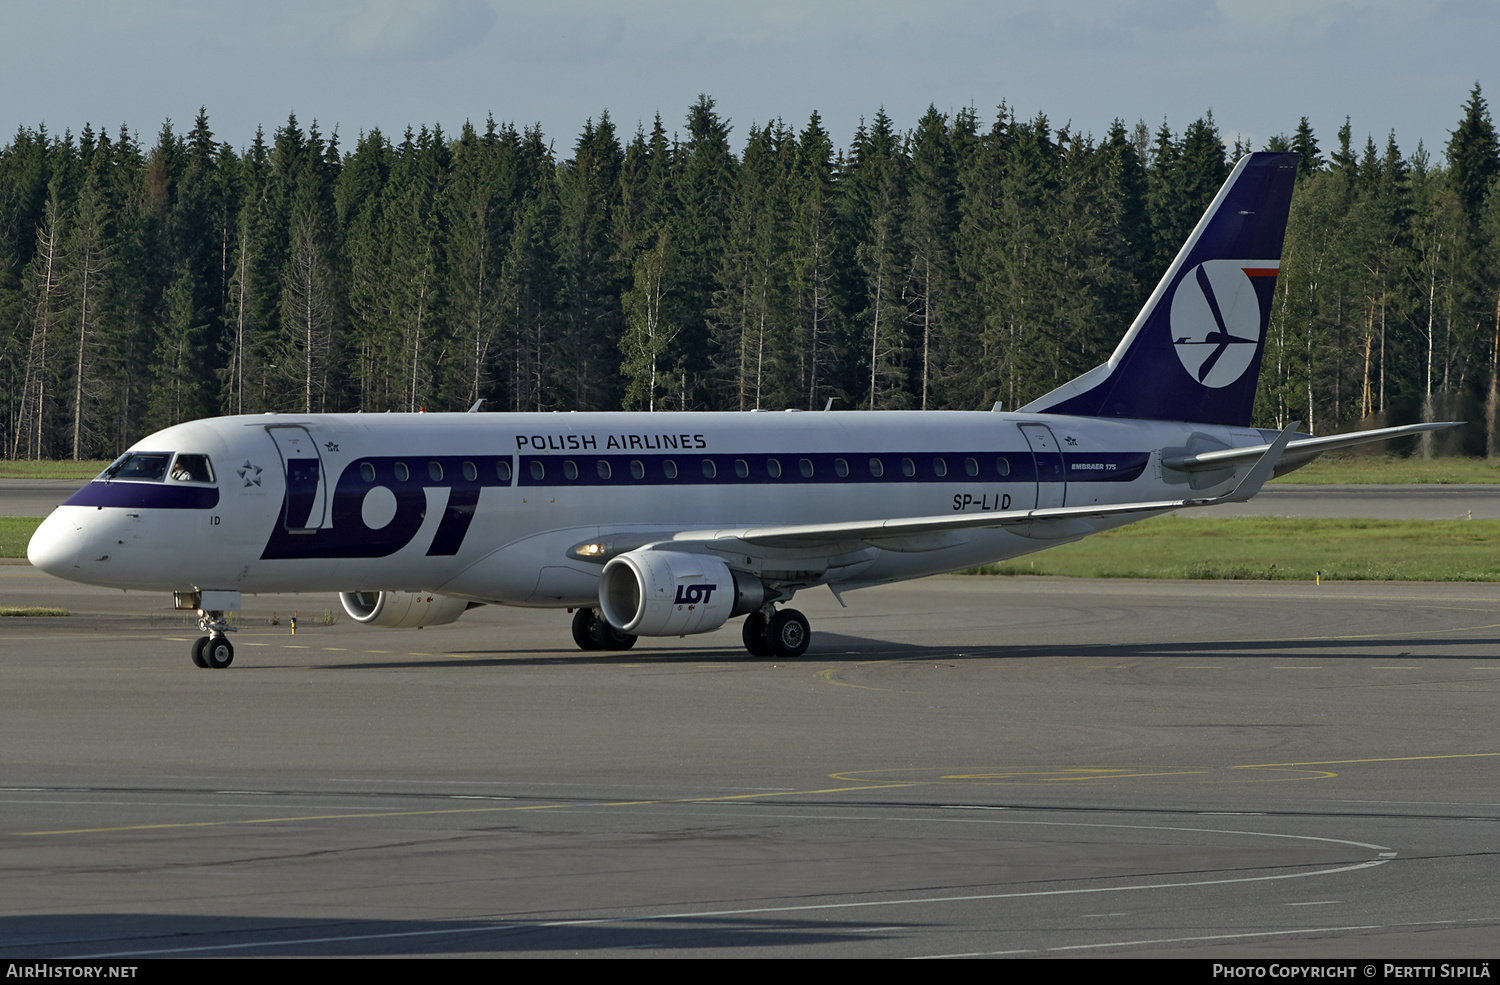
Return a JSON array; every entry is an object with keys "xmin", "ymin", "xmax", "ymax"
[{"xmin": 0, "ymin": 0, "xmax": 1500, "ymax": 160}]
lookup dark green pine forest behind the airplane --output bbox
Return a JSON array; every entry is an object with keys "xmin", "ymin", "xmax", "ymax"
[{"xmin": 0, "ymin": 85, "xmax": 1500, "ymax": 459}]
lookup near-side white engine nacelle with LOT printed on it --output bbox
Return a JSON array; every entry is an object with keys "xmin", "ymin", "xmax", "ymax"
[{"xmin": 599, "ymin": 549, "xmax": 765, "ymax": 636}]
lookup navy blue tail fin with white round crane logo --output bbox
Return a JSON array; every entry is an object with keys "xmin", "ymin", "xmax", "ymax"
[{"xmin": 1020, "ymin": 153, "xmax": 1298, "ymax": 426}]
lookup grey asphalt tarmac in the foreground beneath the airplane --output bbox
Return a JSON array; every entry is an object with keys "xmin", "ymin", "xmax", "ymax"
[{"xmin": 0, "ymin": 562, "xmax": 1500, "ymax": 963}]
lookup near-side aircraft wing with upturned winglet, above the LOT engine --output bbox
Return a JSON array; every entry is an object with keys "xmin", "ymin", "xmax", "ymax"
[{"xmin": 672, "ymin": 421, "xmax": 1301, "ymax": 550}]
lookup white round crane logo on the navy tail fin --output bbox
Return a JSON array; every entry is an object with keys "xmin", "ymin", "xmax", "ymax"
[{"xmin": 1172, "ymin": 259, "xmax": 1277, "ymax": 390}]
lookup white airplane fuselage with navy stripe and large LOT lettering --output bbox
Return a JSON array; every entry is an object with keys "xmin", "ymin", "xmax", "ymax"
[{"xmin": 30, "ymin": 412, "xmax": 1266, "ymax": 606}]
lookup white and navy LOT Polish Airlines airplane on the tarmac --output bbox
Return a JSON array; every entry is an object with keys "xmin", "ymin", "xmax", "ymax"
[{"xmin": 27, "ymin": 153, "xmax": 1452, "ymax": 669}]
